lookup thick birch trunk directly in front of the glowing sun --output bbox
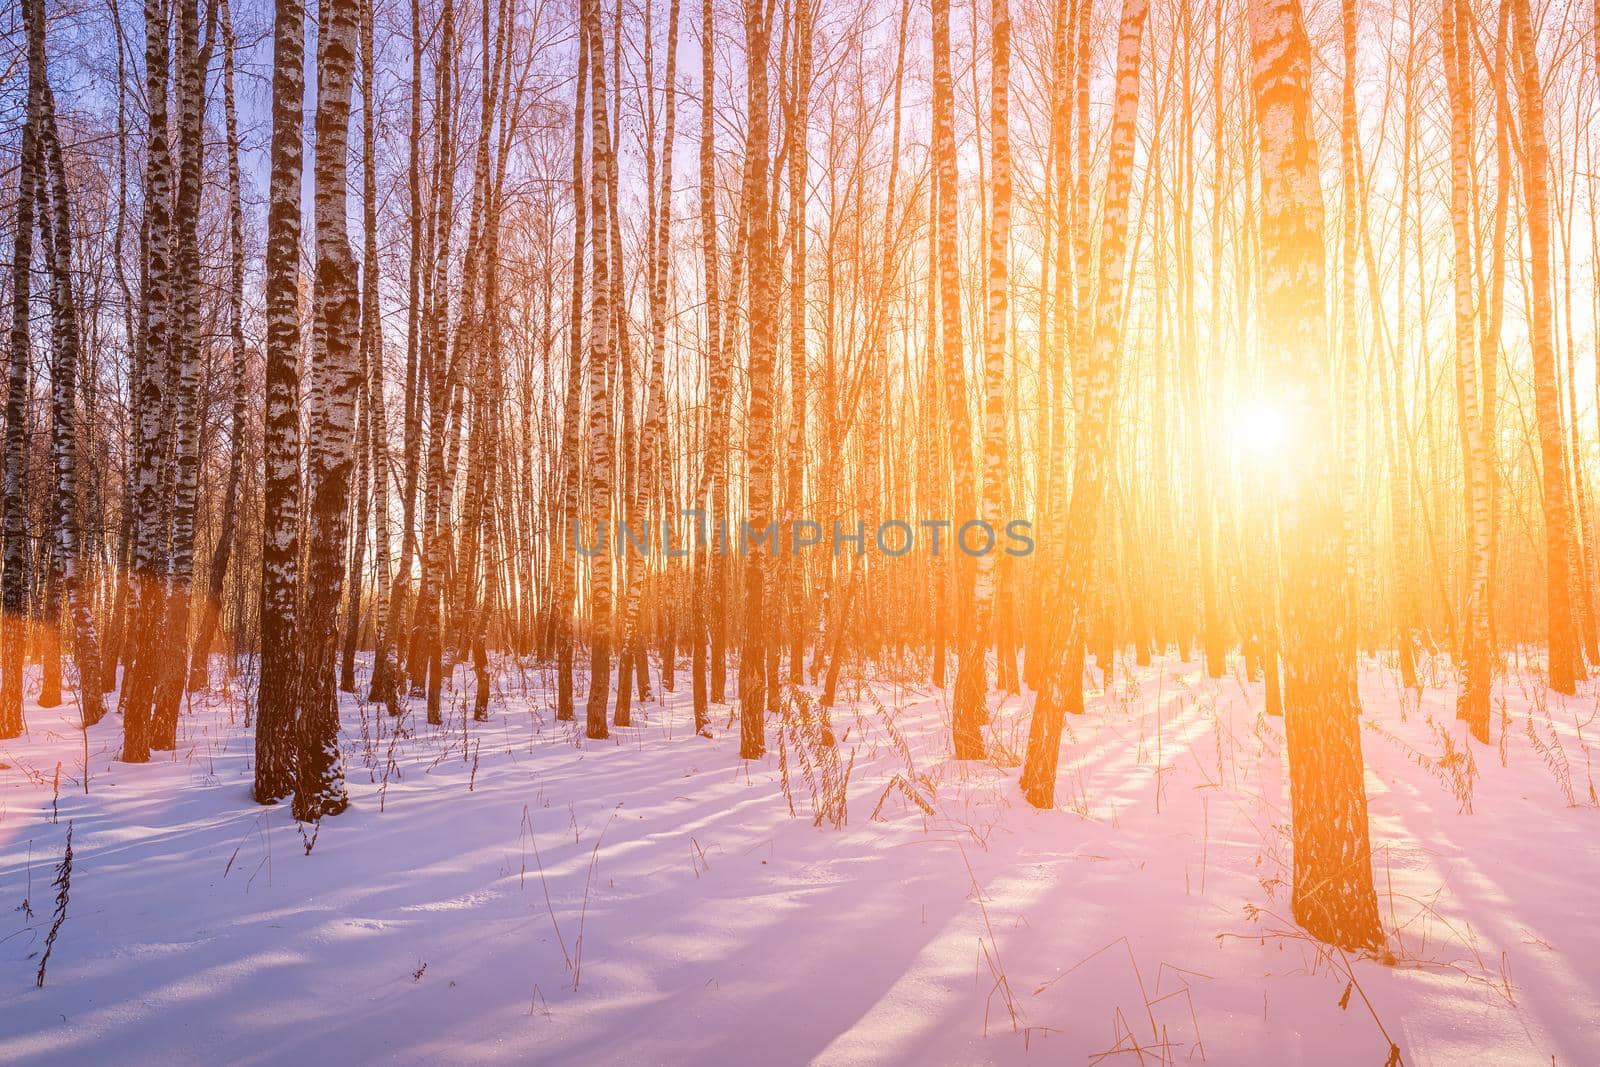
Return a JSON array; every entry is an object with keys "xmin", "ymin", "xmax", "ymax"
[{"xmin": 1250, "ymin": 0, "xmax": 1382, "ymax": 949}]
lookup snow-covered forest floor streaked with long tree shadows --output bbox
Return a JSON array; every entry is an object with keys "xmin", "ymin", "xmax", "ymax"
[{"xmin": 0, "ymin": 646, "xmax": 1600, "ymax": 1067}]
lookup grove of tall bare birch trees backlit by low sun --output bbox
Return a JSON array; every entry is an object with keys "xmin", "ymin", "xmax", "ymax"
[{"xmin": 9, "ymin": 0, "xmax": 1600, "ymax": 950}]
